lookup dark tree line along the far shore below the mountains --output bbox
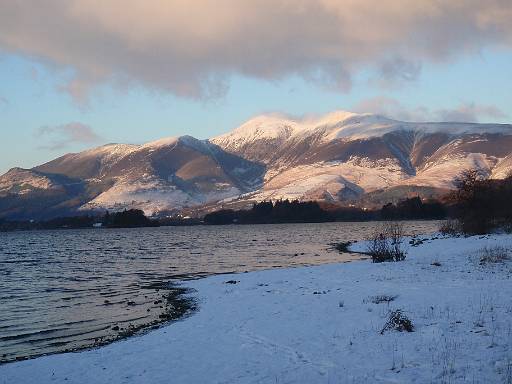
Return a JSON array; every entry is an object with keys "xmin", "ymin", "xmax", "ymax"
[{"xmin": 0, "ymin": 197, "xmax": 446, "ymax": 231}]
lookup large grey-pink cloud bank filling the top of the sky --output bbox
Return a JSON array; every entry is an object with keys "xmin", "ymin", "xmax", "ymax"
[{"xmin": 0, "ymin": 0, "xmax": 512, "ymax": 102}]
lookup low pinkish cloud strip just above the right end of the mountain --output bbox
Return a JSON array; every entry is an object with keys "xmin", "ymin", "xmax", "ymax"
[{"xmin": 352, "ymin": 96, "xmax": 508, "ymax": 122}]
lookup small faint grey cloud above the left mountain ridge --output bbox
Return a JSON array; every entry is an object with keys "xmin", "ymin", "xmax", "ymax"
[{"xmin": 35, "ymin": 122, "xmax": 102, "ymax": 150}]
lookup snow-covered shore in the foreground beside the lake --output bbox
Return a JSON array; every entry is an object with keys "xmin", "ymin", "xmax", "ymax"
[{"xmin": 0, "ymin": 235, "xmax": 512, "ymax": 384}]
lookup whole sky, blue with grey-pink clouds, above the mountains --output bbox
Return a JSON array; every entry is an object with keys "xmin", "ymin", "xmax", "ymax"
[{"xmin": 0, "ymin": 0, "xmax": 512, "ymax": 173}]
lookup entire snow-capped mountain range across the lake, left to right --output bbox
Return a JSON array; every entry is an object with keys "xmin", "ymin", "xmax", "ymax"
[{"xmin": 0, "ymin": 111, "xmax": 512, "ymax": 218}]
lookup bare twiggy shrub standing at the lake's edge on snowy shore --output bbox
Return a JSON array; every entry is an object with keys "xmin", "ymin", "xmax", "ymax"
[{"xmin": 366, "ymin": 222, "xmax": 407, "ymax": 263}]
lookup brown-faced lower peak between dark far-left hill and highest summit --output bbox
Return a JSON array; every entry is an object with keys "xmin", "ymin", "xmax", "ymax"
[{"xmin": 59, "ymin": 136, "xmax": 262, "ymax": 214}]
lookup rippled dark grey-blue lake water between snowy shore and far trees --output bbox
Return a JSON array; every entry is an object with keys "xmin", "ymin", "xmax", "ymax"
[{"xmin": 0, "ymin": 221, "xmax": 437, "ymax": 363}]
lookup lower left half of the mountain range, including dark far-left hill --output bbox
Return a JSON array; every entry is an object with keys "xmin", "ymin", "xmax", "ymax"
[{"xmin": 0, "ymin": 136, "xmax": 265, "ymax": 218}]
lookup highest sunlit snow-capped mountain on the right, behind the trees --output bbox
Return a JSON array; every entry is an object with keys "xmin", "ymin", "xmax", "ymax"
[{"xmin": 211, "ymin": 111, "xmax": 512, "ymax": 206}]
